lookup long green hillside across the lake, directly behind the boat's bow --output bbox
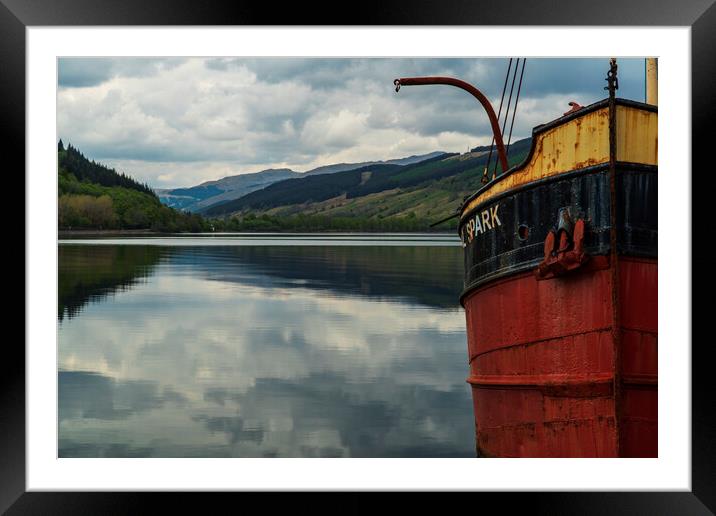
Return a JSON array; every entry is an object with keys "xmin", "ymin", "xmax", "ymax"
[{"xmin": 206, "ymin": 138, "xmax": 531, "ymax": 231}]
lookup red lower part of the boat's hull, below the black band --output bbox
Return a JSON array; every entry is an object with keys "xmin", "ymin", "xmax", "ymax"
[{"xmin": 463, "ymin": 256, "xmax": 658, "ymax": 457}]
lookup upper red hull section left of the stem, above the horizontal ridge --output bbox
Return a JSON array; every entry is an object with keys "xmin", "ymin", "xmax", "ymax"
[{"xmin": 465, "ymin": 269, "xmax": 611, "ymax": 364}]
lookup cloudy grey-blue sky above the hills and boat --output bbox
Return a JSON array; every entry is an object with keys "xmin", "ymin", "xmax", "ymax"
[{"xmin": 57, "ymin": 57, "xmax": 644, "ymax": 188}]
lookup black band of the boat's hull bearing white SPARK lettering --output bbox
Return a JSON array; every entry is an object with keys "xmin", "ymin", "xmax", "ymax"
[{"xmin": 458, "ymin": 163, "xmax": 658, "ymax": 295}]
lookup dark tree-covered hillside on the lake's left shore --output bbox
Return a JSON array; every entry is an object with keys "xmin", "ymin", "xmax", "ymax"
[{"xmin": 57, "ymin": 140, "xmax": 209, "ymax": 232}]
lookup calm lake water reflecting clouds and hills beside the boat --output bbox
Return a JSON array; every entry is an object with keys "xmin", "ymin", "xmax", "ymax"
[{"xmin": 58, "ymin": 235, "xmax": 475, "ymax": 457}]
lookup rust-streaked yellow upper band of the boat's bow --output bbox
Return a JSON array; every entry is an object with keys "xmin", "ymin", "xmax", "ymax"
[{"xmin": 462, "ymin": 105, "xmax": 658, "ymax": 215}]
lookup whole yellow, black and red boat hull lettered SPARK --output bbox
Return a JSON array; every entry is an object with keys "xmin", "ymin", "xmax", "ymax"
[{"xmin": 458, "ymin": 100, "xmax": 658, "ymax": 457}]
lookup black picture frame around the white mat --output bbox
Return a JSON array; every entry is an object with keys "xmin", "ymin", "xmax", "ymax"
[{"xmin": 0, "ymin": 0, "xmax": 716, "ymax": 514}]
